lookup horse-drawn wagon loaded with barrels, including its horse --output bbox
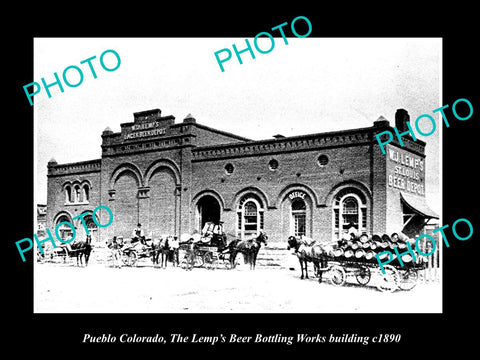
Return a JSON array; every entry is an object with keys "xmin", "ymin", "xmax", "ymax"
[{"xmin": 289, "ymin": 235, "xmax": 425, "ymax": 292}]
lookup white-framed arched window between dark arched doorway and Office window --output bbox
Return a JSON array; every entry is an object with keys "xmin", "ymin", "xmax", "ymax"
[{"xmin": 237, "ymin": 195, "xmax": 264, "ymax": 239}]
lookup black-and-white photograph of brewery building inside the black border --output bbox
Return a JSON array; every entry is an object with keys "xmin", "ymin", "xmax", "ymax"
[{"xmin": 31, "ymin": 36, "xmax": 440, "ymax": 313}]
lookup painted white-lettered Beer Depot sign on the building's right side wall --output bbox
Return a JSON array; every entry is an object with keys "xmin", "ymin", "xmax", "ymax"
[{"xmin": 387, "ymin": 146, "xmax": 425, "ymax": 196}]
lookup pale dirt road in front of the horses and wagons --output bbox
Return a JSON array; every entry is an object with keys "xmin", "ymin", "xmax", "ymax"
[{"xmin": 34, "ymin": 263, "xmax": 442, "ymax": 313}]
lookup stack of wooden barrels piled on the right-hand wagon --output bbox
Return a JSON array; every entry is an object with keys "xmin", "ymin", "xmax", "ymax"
[{"xmin": 333, "ymin": 233, "xmax": 413, "ymax": 263}]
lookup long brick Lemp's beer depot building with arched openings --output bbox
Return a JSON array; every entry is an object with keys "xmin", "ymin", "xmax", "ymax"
[{"xmin": 47, "ymin": 109, "xmax": 436, "ymax": 242}]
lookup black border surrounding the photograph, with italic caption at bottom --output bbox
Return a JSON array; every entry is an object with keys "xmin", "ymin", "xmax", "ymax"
[{"xmin": 3, "ymin": 2, "xmax": 480, "ymax": 357}]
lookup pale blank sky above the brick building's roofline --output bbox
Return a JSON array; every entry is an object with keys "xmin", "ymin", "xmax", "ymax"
[{"xmin": 33, "ymin": 37, "xmax": 443, "ymax": 213}]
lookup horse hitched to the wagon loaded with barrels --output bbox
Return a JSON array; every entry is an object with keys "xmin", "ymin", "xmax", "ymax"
[{"xmin": 287, "ymin": 236, "xmax": 327, "ymax": 282}]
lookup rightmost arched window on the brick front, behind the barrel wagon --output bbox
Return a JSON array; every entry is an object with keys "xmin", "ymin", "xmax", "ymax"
[{"xmin": 333, "ymin": 188, "xmax": 367, "ymax": 239}]
